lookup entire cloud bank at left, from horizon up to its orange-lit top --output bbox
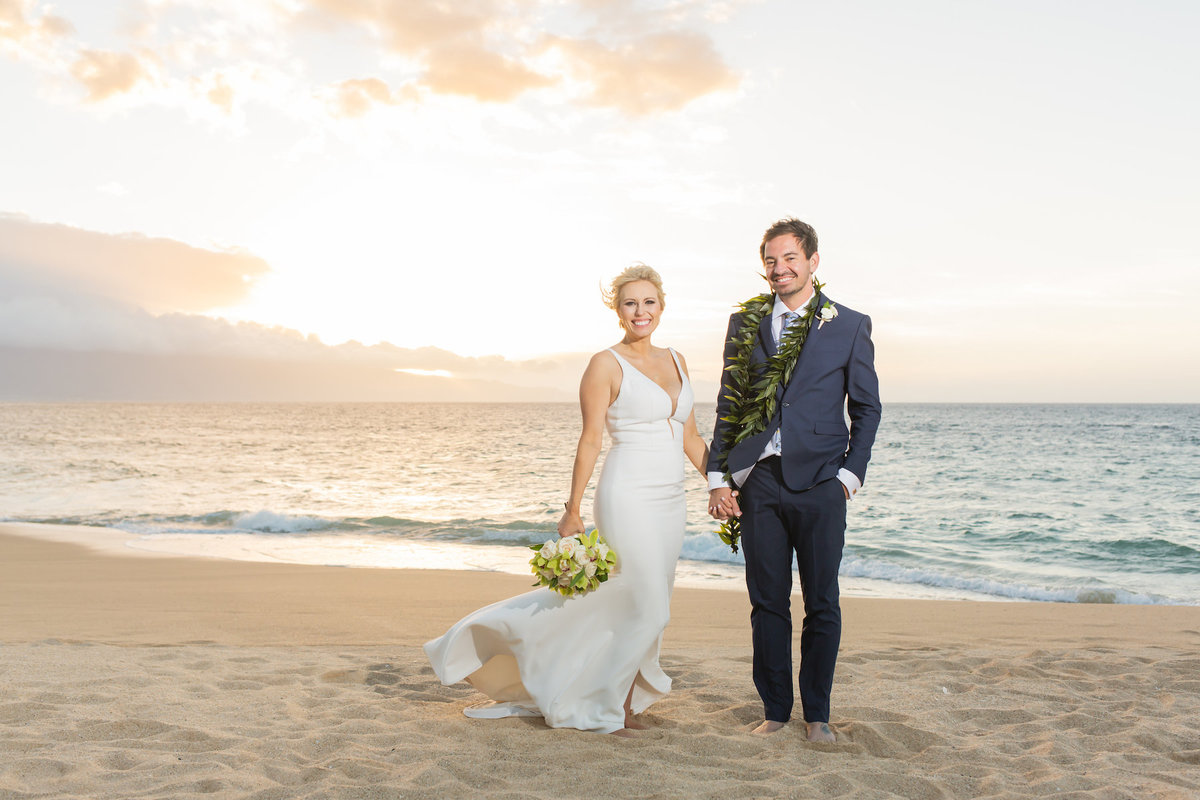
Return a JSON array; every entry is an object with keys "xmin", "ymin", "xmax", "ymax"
[{"xmin": 0, "ymin": 215, "xmax": 576, "ymax": 402}]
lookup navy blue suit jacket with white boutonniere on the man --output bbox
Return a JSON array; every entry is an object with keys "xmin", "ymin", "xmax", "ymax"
[{"xmin": 708, "ymin": 294, "xmax": 882, "ymax": 492}]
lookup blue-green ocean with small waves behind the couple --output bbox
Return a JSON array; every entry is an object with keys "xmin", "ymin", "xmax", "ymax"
[{"xmin": 0, "ymin": 403, "xmax": 1200, "ymax": 604}]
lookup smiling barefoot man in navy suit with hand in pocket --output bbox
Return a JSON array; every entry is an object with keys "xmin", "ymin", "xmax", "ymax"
[{"xmin": 708, "ymin": 219, "xmax": 881, "ymax": 741}]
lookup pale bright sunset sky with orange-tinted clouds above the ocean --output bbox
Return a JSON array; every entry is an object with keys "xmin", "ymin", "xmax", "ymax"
[{"xmin": 0, "ymin": 0, "xmax": 1200, "ymax": 402}]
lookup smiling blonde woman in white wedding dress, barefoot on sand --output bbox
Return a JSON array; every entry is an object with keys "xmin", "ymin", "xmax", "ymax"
[{"xmin": 425, "ymin": 264, "xmax": 708, "ymax": 735}]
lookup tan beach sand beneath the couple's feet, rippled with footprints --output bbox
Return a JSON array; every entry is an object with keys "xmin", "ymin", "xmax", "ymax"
[{"xmin": 0, "ymin": 525, "xmax": 1200, "ymax": 800}]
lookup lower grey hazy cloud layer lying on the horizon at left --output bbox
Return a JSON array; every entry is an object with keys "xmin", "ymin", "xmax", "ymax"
[{"xmin": 0, "ymin": 272, "xmax": 588, "ymax": 402}]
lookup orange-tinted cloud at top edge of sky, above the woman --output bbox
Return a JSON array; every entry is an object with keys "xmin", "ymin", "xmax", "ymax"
[{"xmin": 300, "ymin": 0, "xmax": 738, "ymax": 115}]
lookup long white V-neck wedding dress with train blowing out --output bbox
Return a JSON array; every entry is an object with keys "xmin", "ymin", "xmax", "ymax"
[{"xmin": 425, "ymin": 350, "xmax": 694, "ymax": 733}]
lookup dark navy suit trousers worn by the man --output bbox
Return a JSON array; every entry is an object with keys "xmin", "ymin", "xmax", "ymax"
[{"xmin": 738, "ymin": 457, "xmax": 846, "ymax": 722}]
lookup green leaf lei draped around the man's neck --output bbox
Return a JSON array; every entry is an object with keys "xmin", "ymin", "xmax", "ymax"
[{"xmin": 716, "ymin": 278, "xmax": 824, "ymax": 553}]
